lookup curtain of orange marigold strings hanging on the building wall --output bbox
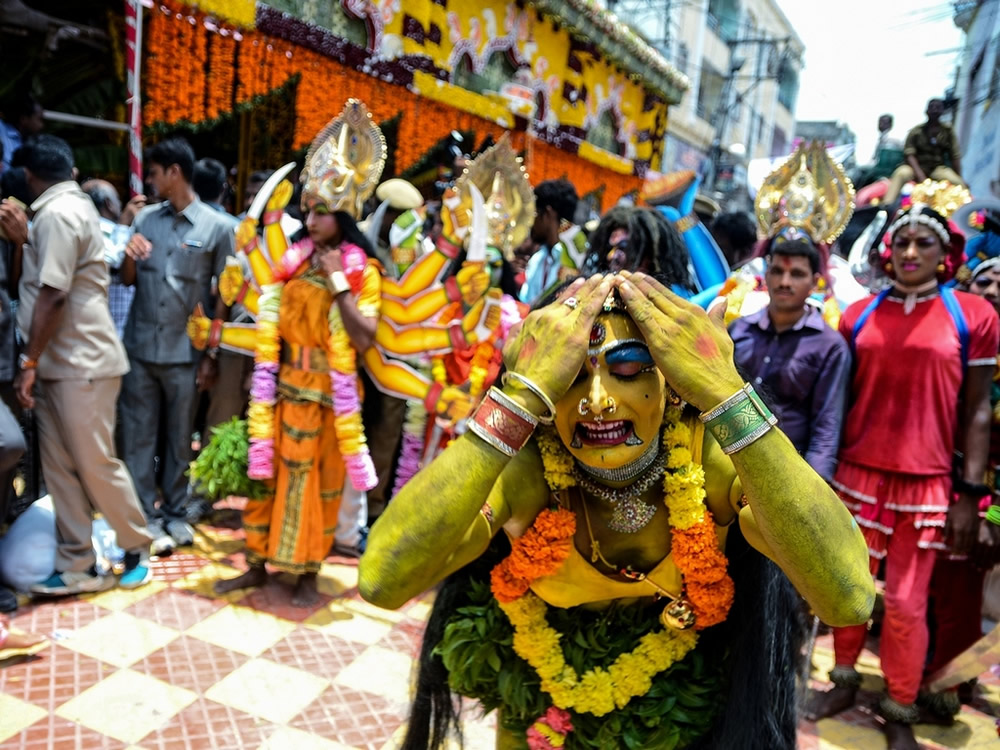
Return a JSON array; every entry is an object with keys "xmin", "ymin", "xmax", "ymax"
[{"xmin": 143, "ymin": 0, "xmax": 642, "ymax": 208}]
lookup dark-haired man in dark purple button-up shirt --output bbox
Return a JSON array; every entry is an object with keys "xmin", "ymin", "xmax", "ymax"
[{"xmin": 729, "ymin": 239, "xmax": 851, "ymax": 481}]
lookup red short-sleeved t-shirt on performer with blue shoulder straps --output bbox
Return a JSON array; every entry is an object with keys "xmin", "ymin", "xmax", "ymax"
[{"xmin": 840, "ymin": 292, "xmax": 1000, "ymax": 475}]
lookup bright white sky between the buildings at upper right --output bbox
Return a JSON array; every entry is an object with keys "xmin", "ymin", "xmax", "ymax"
[{"xmin": 778, "ymin": 0, "xmax": 963, "ymax": 163}]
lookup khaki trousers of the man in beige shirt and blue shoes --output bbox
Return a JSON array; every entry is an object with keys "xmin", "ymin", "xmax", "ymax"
[{"xmin": 35, "ymin": 378, "xmax": 151, "ymax": 573}]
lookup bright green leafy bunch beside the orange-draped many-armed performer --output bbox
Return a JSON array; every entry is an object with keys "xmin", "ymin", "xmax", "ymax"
[{"xmin": 188, "ymin": 417, "xmax": 268, "ymax": 501}]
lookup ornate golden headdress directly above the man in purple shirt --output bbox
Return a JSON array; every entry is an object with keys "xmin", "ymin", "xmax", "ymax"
[{"xmin": 754, "ymin": 141, "xmax": 854, "ymax": 243}]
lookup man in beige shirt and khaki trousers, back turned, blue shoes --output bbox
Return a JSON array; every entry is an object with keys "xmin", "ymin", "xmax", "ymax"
[{"xmin": 14, "ymin": 136, "xmax": 152, "ymax": 595}]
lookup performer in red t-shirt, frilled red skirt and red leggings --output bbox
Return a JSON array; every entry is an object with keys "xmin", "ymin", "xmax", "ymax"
[{"xmin": 806, "ymin": 204, "xmax": 1000, "ymax": 750}]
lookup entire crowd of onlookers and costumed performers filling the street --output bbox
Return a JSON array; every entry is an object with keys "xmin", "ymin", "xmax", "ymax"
[{"xmin": 0, "ymin": 94, "xmax": 1000, "ymax": 749}]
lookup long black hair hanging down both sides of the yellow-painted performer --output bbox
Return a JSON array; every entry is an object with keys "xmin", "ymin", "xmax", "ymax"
[{"xmin": 402, "ymin": 524, "xmax": 805, "ymax": 750}]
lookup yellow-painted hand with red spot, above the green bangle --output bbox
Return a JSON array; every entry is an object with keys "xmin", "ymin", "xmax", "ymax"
[{"xmin": 616, "ymin": 271, "xmax": 743, "ymax": 411}]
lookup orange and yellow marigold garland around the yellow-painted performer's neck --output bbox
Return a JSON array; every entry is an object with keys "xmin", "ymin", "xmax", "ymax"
[{"xmin": 490, "ymin": 409, "xmax": 734, "ymax": 716}]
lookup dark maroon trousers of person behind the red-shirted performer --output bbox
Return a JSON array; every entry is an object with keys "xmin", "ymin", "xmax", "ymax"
[{"xmin": 927, "ymin": 557, "xmax": 986, "ymax": 675}]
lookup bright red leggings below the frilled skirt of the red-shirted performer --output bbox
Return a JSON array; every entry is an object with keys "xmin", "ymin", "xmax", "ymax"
[{"xmin": 833, "ymin": 512, "xmax": 938, "ymax": 706}]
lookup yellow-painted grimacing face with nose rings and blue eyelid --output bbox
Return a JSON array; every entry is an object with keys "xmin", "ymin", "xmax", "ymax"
[{"xmin": 556, "ymin": 311, "xmax": 666, "ymax": 469}]
